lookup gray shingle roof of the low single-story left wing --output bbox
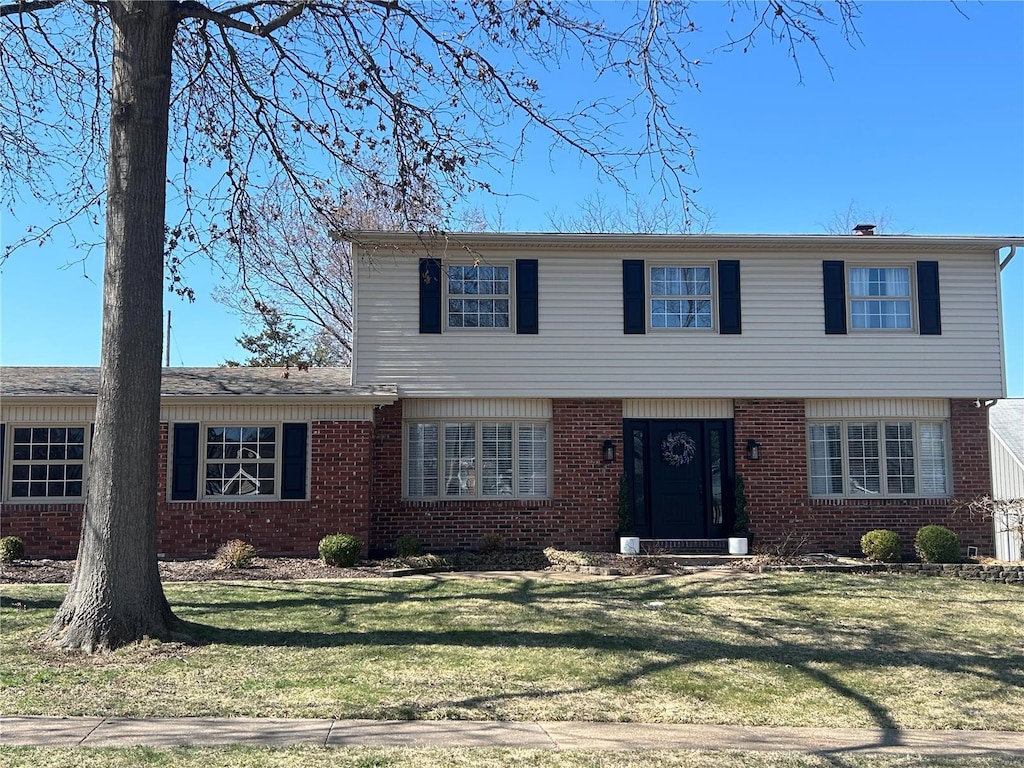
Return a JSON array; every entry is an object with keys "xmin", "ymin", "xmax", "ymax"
[{"xmin": 0, "ymin": 367, "xmax": 397, "ymax": 401}]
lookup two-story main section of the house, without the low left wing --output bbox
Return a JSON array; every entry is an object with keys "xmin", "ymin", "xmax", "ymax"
[{"xmin": 352, "ymin": 232, "xmax": 1010, "ymax": 553}]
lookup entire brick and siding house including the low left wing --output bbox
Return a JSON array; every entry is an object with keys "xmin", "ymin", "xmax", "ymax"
[{"xmin": 0, "ymin": 232, "xmax": 1022, "ymax": 556}]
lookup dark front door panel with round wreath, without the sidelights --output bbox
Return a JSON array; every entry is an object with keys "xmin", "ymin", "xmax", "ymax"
[{"xmin": 648, "ymin": 421, "xmax": 708, "ymax": 539}]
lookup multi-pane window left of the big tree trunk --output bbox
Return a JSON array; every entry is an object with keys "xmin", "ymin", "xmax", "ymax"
[{"xmin": 9, "ymin": 426, "xmax": 88, "ymax": 501}]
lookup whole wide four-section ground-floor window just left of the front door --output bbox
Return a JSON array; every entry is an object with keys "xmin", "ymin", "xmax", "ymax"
[{"xmin": 404, "ymin": 421, "xmax": 551, "ymax": 499}]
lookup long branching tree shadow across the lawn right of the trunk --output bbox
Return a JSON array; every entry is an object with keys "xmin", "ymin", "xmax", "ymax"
[{"xmin": 169, "ymin": 580, "xmax": 1024, "ymax": 744}]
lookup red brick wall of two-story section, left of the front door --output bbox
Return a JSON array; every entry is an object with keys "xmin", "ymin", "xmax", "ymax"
[{"xmin": 371, "ymin": 400, "xmax": 623, "ymax": 552}]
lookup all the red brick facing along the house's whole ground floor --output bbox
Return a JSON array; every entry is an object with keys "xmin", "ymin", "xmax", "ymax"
[{"xmin": 0, "ymin": 399, "xmax": 993, "ymax": 557}]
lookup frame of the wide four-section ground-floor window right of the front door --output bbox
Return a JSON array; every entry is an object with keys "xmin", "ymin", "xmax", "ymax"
[{"xmin": 806, "ymin": 417, "xmax": 952, "ymax": 500}]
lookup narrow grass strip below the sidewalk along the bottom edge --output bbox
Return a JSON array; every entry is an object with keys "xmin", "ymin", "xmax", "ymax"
[{"xmin": 0, "ymin": 748, "xmax": 1024, "ymax": 768}]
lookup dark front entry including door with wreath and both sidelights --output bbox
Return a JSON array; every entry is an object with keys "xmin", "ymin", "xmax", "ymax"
[{"xmin": 625, "ymin": 419, "xmax": 732, "ymax": 539}]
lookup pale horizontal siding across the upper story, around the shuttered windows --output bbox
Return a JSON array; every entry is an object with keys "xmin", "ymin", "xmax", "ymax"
[{"xmin": 353, "ymin": 250, "xmax": 1004, "ymax": 399}]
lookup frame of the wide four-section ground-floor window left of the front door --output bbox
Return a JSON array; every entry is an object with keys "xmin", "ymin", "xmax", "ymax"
[{"xmin": 401, "ymin": 417, "xmax": 554, "ymax": 502}]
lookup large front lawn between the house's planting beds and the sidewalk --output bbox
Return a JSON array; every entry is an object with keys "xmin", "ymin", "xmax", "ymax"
[{"xmin": 6, "ymin": 573, "xmax": 1024, "ymax": 733}]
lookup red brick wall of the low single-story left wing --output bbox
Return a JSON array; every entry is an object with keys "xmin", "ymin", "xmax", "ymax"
[{"xmin": 3, "ymin": 421, "xmax": 372, "ymax": 558}]
